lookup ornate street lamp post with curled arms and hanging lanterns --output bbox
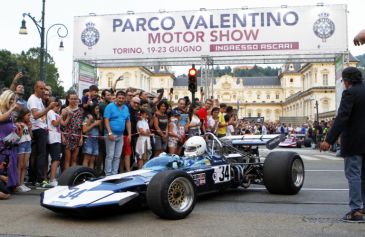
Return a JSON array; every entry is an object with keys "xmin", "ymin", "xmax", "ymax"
[{"xmin": 19, "ymin": 0, "xmax": 68, "ymax": 81}]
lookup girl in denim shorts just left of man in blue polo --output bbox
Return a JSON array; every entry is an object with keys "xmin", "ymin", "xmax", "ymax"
[{"xmin": 82, "ymin": 105, "xmax": 102, "ymax": 169}]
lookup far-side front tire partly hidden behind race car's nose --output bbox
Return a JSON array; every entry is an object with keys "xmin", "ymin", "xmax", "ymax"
[{"xmin": 58, "ymin": 166, "xmax": 97, "ymax": 187}]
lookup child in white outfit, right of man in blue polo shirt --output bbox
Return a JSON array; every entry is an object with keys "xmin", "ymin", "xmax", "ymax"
[{"xmin": 136, "ymin": 109, "xmax": 151, "ymax": 169}]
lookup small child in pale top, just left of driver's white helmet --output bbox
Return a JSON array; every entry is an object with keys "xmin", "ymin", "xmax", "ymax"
[{"xmin": 168, "ymin": 110, "xmax": 182, "ymax": 155}]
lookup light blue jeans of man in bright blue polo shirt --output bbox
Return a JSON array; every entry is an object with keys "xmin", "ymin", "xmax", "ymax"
[{"xmin": 104, "ymin": 135, "xmax": 123, "ymax": 175}]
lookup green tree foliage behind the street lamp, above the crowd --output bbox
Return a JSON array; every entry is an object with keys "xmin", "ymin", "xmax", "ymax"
[{"xmin": 0, "ymin": 48, "xmax": 65, "ymax": 98}]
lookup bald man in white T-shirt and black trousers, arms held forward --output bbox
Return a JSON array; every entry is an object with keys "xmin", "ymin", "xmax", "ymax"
[{"xmin": 27, "ymin": 81, "xmax": 57, "ymax": 185}]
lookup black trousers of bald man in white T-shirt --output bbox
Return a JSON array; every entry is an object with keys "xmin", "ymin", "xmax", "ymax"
[{"xmin": 33, "ymin": 128, "xmax": 48, "ymax": 182}]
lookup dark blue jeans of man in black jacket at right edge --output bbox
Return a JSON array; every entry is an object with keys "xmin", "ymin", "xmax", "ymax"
[{"xmin": 345, "ymin": 155, "xmax": 365, "ymax": 211}]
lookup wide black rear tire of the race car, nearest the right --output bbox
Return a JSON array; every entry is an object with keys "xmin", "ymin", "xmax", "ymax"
[{"xmin": 264, "ymin": 151, "xmax": 304, "ymax": 195}]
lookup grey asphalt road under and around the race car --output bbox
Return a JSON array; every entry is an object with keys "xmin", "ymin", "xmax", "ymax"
[{"xmin": 0, "ymin": 149, "xmax": 365, "ymax": 237}]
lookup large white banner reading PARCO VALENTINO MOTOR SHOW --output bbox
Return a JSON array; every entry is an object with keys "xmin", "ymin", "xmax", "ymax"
[{"xmin": 74, "ymin": 5, "xmax": 347, "ymax": 60}]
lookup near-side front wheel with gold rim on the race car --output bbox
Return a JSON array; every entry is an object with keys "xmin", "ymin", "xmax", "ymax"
[{"xmin": 147, "ymin": 170, "xmax": 196, "ymax": 220}]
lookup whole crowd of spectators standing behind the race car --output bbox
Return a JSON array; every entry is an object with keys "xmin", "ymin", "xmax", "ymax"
[{"xmin": 0, "ymin": 73, "xmax": 336, "ymax": 199}]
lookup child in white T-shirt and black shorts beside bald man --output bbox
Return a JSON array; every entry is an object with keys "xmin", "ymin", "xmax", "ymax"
[{"xmin": 47, "ymin": 99, "xmax": 63, "ymax": 187}]
